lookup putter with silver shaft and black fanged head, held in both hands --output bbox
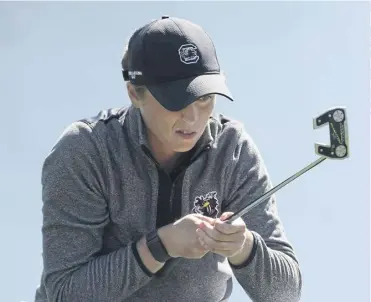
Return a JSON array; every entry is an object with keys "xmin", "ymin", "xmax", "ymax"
[{"xmin": 159, "ymin": 107, "xmax": 349, "ymax": 276}]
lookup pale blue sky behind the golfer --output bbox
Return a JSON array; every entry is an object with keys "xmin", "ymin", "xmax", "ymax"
[{"xmin": 0, "ymin": 2, "xmax": 370, "ymax": 302}]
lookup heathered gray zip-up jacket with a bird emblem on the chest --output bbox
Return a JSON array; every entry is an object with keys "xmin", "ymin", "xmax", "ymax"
[{"xmin": 35, "ymin": 107, "xmax": 302, "ymax": 302}]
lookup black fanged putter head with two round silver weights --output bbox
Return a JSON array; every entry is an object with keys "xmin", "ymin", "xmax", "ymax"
[{"xmin": 313, "ymin": 107, "xmax": 349, "ymax": 159}]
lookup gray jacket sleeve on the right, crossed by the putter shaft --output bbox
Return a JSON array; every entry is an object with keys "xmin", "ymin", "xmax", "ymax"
[{"xmin": 223, "ymin": 132, "xmax": 302, "ymax": 302}]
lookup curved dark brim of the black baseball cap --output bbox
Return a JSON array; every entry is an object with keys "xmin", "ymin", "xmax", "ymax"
[{"xmin": 147, "ymin": 74, "xmax": 233, "ymax": 111}]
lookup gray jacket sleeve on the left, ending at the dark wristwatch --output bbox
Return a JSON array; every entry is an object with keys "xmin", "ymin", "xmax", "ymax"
[{"xmin": 38, "ymin": 122, "xmax": 151, "ymax": 302}]
